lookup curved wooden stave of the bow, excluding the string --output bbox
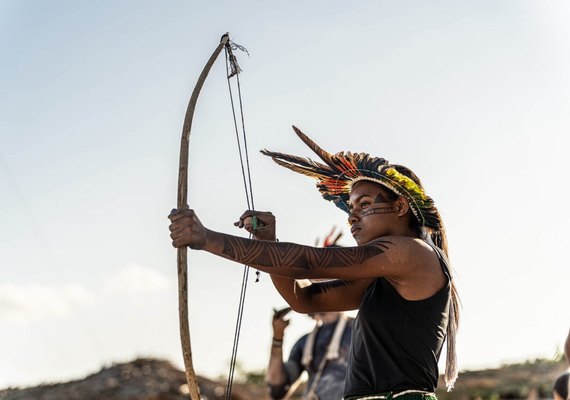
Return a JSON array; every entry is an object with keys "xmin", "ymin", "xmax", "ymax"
[{"xmin": 177, "ymin": 33, "xmax": 229, "ymax": 400}]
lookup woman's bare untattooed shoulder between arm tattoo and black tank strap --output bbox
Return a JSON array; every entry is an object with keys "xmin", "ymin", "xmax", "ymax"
[{"xmin": 374, "ymin": 236, "xmax": 447, "ymax": 300}]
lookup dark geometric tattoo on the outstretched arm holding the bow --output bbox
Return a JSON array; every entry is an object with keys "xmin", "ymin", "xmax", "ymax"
[{"xmin": 222, "ymin": 235, "xmax": 391, "ymax": 270}]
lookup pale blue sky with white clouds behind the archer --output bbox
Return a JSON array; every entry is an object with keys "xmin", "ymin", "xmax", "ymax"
[{"xmin": 0, "ymin": 0, "xmax": 570, "ymax": 388}]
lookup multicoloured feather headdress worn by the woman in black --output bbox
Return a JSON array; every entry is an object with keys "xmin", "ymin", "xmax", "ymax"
[{"xmin": 261, "ymin": 126, "xmax": 441, "ymax": 230}]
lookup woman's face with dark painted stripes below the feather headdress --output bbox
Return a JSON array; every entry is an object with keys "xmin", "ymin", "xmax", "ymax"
[{"xmin": 348, "ymin": 181, "xmax": 401, "ymax": 245}]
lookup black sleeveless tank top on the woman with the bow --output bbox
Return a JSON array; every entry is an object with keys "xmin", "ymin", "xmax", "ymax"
[{"xmin": 345, "ymin": 247, "xmax": 451, "ymax": 396}]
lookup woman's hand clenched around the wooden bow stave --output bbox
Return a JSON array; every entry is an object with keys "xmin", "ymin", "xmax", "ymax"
[{"xmin": 168, "ymin": 208, "xmax": 208, "ymax": 250}]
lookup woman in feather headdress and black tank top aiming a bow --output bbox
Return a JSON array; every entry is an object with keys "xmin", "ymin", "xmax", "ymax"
[{"xmin": 169, "ymin": 127, "xmax": 458, "ymax": 400}]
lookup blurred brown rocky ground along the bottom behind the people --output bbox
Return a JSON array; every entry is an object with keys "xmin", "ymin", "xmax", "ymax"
[{"xmin": 0, "ymin": 359, "xmax": 568, "ymax": 400}]
